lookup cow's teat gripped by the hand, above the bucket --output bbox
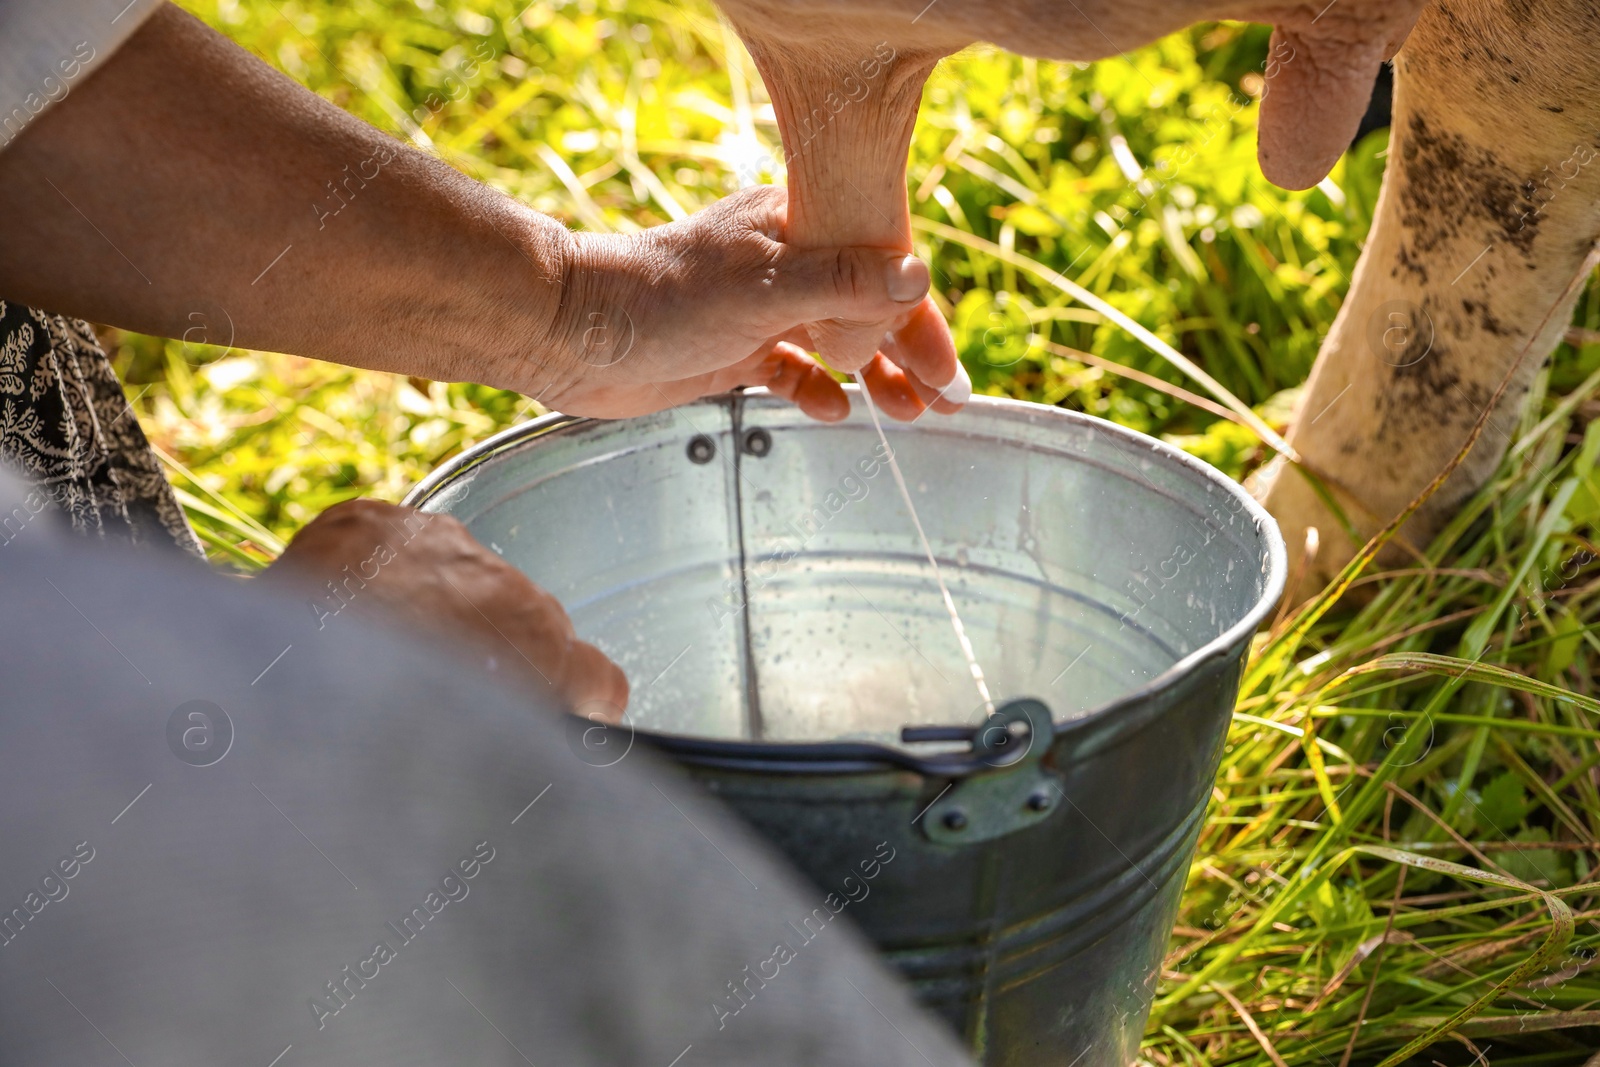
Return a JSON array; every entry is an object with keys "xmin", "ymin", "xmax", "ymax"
[{"xmin": 741, "ymin": 30, "xmax": 944, "ymax": 370}]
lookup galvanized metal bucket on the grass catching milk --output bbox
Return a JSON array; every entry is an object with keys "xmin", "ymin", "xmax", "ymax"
[{"xmin": 408, "ymin": 392, "xmax": 1285, "ymax": 1067}]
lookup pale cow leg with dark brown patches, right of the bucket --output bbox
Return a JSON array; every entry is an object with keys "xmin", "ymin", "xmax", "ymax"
[{"xmin": 1258, "ymin": 0, "xmax": 1600, "ymax": 595}]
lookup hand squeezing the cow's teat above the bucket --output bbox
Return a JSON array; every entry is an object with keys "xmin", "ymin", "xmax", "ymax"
[{"xmin": 538, "ymin": 186, "xmax": 970, "ymax": 421}]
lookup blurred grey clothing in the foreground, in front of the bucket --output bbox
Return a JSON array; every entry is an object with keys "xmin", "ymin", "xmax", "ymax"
[{"xmin": 0, "ymin": 476, "xmax": 968, "ymax": 1067}]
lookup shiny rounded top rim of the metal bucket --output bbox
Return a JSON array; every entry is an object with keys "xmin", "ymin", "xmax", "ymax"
[{"xmin": 402, "ymin": 384, "xmax": 1288, "ymax": 777}]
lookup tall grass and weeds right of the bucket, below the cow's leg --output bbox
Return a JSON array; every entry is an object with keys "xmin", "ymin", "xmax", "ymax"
[{"xmin": 1146, "ymin": 379, "xmax": 1600, "ymax": 1064}]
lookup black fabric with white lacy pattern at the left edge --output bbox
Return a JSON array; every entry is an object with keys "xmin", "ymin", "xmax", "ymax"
[{"xmin": 0, "ymin": 301, "xmax": 205, "ymax": 558}]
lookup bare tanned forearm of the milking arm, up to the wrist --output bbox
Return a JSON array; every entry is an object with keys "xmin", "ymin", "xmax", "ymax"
[{"xmin": 0, "ymin": 8, "xmax": 571, "ymax": 394}]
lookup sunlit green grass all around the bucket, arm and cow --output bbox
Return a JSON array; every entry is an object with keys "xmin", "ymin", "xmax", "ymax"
[{"xmin": 112, "ymin": 0, "xmax": 1600, "ymax": 1067}]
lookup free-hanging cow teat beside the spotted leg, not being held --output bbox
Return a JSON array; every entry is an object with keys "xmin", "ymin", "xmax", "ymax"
[{"xmin": 1256, "ymin": 0, "xmax": 1422, "ymax": 189}]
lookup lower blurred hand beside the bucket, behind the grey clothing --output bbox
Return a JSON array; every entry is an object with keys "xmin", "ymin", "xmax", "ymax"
[{"xmin": 259, "ymin": 501, "xmax": 627, "ymax": 721}]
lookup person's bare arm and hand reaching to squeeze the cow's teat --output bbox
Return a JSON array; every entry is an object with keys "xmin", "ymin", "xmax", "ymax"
[{"xmin": 0, "ymin": 5, "xmax": 954, "ymax": 418}]
